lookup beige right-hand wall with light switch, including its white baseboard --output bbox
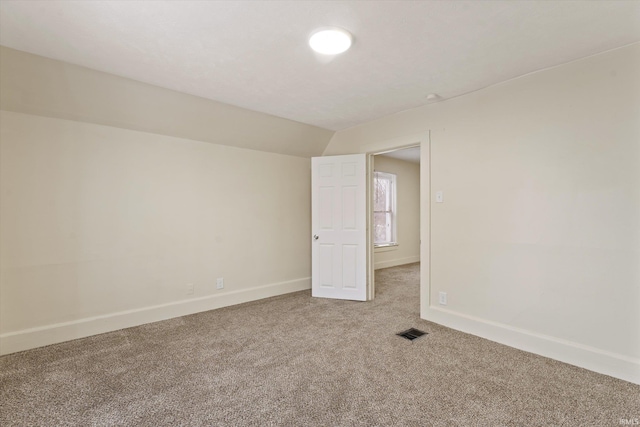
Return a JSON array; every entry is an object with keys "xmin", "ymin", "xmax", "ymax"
[{"xmin": 325, "ymin": 44, "xmax": 640, "ymax": 382}]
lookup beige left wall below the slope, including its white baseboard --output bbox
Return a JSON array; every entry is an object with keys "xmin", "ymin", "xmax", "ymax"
[{"xmin": 0, "ymin": 111, "xmax": 311, "ymax": 353}]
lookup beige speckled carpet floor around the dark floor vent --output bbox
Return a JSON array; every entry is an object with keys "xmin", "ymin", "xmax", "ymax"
[{"xmin": 0, "ymin": 264, "xmax": 640, "ymax": 426}]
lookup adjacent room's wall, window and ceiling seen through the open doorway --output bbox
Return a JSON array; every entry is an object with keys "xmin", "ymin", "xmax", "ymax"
[{"xmin": 370, "ymin": 145, "xmax": 421, "ymax": 296}]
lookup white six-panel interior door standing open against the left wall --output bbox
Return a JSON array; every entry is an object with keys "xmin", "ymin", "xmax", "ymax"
[{"xmin": 311, "ymin": 154, "xmax": 367, "ymax": 301}]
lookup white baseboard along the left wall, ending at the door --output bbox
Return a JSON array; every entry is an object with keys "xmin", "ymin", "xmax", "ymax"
[{"xmin": 0, "ymin": 277, "xmax": 311, "ymax": 355}]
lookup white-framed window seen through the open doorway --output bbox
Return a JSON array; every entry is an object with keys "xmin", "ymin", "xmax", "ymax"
[{"xmin": 373, "ymin": 172, "xmax": 397, "ymax": 246}]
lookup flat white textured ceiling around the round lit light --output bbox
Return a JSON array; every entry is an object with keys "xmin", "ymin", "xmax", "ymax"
[{"xmin": 0, "ymin": 0, "xmax": 640, "ymax": 130}]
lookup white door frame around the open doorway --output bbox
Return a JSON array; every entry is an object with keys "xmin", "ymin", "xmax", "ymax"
[{"xmin": 367, "ymin": 132, "xmax": 431, "ymax": 319}]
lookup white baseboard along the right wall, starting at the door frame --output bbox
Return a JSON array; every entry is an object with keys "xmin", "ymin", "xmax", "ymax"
[{"xmin": 422, "ymin": 306, "xmax": 640, "ymax": 384}]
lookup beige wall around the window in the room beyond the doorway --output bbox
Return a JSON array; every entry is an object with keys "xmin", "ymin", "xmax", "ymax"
[{"xmin": 374, "ymin": 155, "xmax": 420, "ymax": 269}]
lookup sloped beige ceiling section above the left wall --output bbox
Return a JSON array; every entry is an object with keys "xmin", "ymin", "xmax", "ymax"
[{"xmin": 0, "ymin": 47, "xmax": 334, "ymax": 157}]
